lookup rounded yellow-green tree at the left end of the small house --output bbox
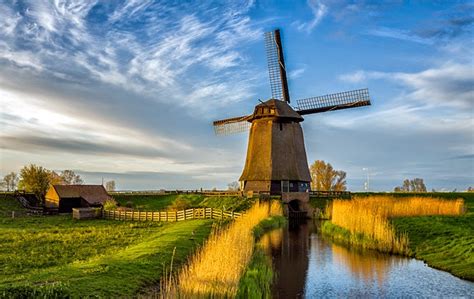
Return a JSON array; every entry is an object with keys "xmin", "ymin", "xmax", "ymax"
[{"xmin": 18, "ymin": 164, "xmax": 52, "ymax": 200}]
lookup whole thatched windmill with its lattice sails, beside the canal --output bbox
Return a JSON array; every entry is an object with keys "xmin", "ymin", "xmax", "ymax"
[{"xmin": 213, "ymin": 30, "xmax": 370, "ymax": 194}]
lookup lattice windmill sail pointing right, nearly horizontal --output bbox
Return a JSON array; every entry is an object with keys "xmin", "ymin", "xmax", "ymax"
[{"xmin": 296, "ymin": 88, "xmax": 370, "ymax": 115}]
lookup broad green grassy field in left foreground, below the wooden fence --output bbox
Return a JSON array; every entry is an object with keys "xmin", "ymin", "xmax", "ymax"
[{"xmin": 0, "ymin": 216, "xmax": 212, "ymax": 297}]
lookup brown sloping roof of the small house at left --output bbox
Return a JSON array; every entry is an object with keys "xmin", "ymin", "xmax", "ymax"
[{"xmin": 53, "ymin": 185, "xmax": 112, "ymax": 205}]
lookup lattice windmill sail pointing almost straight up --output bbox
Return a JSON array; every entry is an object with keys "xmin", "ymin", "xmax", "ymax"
[{"xmin": 265, "ymin": 30, "xmax": 290, "ymax": 103}]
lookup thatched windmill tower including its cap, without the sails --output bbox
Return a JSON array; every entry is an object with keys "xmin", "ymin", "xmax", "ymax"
[{"xmin": 240, "ymin": 99, "xmax": 311, "ymax": 194}]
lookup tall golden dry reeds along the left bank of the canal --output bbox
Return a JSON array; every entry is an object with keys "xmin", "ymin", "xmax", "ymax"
[{"xmin": 161, "ymin": 202, "xmax": 283, "ymax": 298}]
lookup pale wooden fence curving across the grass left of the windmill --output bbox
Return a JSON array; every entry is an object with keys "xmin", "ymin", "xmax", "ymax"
[{"xmin": 102, "ymin": 208, "xmax": 242, "ymax": 222}]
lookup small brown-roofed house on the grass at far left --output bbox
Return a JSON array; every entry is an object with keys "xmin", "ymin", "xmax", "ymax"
[{"xmin": 45, "ymin": 185, "xmax": 113, "ymax": 213}]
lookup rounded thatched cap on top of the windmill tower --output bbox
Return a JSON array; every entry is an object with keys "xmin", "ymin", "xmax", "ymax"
[{"xmin": 249, "ymin": 99, "xmax": 304, "ymax": 122}]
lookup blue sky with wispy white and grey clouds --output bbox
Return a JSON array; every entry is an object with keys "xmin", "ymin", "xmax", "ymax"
[{"xmin": 0, "ymin": 0, "xmax": 474, "ymax": 191}]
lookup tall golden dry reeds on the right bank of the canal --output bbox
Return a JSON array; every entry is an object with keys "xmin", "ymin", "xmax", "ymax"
[{"xmin": 330, "ymin": 196, "xmax": 464, "ymax": 253}]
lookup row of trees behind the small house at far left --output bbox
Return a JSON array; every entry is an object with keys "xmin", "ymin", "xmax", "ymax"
[{"xmin": 0, "ymin": 164, "xmax": 115, "ymax": 199}]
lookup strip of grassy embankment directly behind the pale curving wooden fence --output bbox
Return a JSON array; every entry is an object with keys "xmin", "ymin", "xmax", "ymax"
[{"xmin": 113, "ymin": 194, "xmax": 253, "ymax": 212}]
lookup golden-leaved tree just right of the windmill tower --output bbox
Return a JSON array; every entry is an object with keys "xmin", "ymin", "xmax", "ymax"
[{"xmin": 309, "ymin": 160, "xmax": 346, "ymax": 191}]
